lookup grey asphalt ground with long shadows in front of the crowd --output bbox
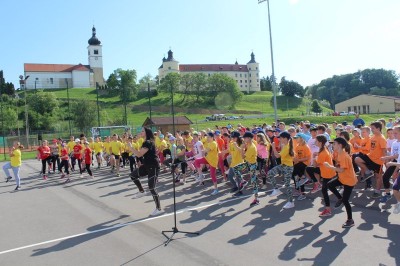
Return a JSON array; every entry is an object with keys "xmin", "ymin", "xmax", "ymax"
[{"xmin": 0, "ymin": 160, "xmax": 400, "ymax": 265}]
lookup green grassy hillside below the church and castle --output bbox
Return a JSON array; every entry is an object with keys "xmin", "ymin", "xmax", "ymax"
[{"xmin": 46, "ymin": 88, "xmax": 332, "ymax": 126}]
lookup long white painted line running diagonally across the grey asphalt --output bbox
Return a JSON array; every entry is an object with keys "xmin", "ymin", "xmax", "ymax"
[{"xmin": 0, "ymin": 192, "xmax": 258, "ymax": 255}]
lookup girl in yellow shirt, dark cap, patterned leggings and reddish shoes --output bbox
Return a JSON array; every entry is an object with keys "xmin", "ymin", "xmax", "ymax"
[{"xmin": 233, "ymin": 131, "xmax": 260, "ymax": 207}]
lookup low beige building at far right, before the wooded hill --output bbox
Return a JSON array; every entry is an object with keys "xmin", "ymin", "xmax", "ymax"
[{"xmin": 335, "ymin": 94, "xmax": 400, "ymax": 114}]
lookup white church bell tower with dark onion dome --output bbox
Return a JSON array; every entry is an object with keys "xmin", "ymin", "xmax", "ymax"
[{"xmin": 88, "ymin": 26, "xmax": 104, "ymax": 88}]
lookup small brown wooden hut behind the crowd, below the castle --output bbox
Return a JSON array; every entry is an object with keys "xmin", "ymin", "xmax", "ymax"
[{"xmin": 143, "ymin": 116, "xmax": 193, "ymax": 134}]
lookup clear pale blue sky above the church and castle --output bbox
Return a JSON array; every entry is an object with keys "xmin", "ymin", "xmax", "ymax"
[{"xmin": 0, "ymin": 0, "xmax": 400, "ymax": 87}]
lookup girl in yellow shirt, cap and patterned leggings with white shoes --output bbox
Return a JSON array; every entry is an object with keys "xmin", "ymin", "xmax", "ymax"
[{"xmin": 268, "ymin": 131, "xmax": 294, "ymax": 209}]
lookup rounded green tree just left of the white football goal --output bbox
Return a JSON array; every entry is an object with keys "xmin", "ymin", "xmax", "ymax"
[{"xmin": 71, "ymin": 100, "xmax": 97, "ymax": 131}]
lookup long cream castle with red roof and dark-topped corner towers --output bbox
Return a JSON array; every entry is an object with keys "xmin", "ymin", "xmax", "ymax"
[{"xmin": 158, "ymin": 50, "xmax": 260, "ymax": 92}]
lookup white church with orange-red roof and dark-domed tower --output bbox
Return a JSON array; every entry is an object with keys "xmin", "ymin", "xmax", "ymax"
[{"xmin": 24, "ymin": 26, "xmax": 105, "ymax": 89}]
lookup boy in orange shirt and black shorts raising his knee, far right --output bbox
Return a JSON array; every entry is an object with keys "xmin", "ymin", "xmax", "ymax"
[{"xmin": 355, "ymin": 121, "xmax": 386, "ymax": 196}]
